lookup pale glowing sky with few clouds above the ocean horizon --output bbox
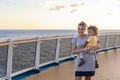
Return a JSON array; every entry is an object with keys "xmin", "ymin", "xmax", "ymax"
[{"xmin": 0, "ymin": 0, "xmax": 120, "ymax": 30}]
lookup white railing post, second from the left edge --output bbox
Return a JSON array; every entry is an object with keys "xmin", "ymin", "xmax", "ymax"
[{"xmin": 35, "ymin": 38, "xmax": 40, "ymax": 69}]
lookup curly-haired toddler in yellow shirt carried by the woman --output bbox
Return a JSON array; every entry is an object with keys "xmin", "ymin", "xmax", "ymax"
[{"xmin": 78, "ymin": 26, "xmax": 99, "ymax": 68}]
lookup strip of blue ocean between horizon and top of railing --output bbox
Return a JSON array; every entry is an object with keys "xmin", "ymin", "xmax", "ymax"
[{"xmin": 0, "ymin": 30, "xmax": 120, "ymax": 38}]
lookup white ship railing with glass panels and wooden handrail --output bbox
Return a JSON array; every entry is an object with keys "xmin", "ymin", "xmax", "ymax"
[{"xmin": 0, "ymin": 33, "xmax": 120, "ymax": 80}]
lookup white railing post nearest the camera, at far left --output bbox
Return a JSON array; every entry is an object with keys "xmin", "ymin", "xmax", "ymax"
[{"xmin": 7, "ymin": 39, "xmax": 13, "ymax": 80}]
